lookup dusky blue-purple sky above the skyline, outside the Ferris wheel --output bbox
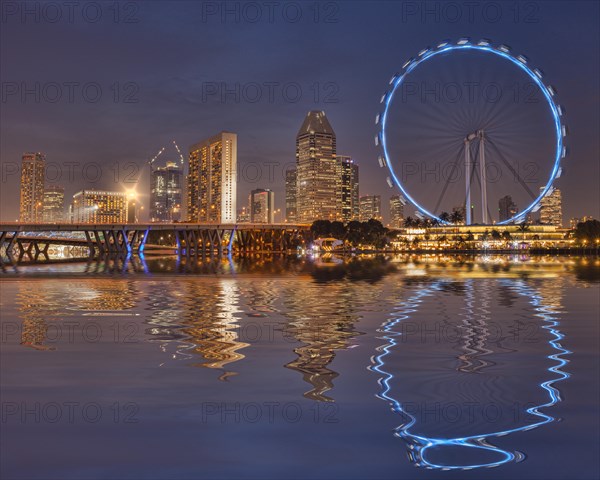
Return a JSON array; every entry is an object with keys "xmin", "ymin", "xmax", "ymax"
[{"xmin": 0, "ymin": 0, "xmax": 600, "ymax": 224}]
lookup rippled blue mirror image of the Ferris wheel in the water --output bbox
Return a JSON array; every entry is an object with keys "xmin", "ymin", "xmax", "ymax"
[{"xmin": 370, "ymin": 279, "xmax": 572, "ymax": 470}]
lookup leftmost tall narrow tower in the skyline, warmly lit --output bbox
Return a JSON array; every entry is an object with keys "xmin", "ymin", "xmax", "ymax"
[{"xmin": 19, "ymin": 153, "xmax": 46, "ymax": 222}]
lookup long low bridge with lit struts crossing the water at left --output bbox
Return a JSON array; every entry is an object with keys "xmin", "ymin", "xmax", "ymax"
[{"xmin": 0, "ymin": 223, "xmax": 311, "ymax": 262}]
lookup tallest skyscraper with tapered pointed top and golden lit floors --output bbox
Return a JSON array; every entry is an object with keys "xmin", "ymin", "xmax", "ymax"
[{"xmin": 296, "ymin": 111, "xmax": 342, "ymax": 222}]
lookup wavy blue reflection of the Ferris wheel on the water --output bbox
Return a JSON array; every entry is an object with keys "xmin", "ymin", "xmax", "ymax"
[{"xmin": 371, "ymin": 279, "xmax": 572, "ymax": 470}]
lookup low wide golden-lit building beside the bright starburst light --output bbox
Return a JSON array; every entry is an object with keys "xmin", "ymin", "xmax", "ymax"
[{"xmin": 72, "ymin": 190, "xmax": 129, "ymax": 223}]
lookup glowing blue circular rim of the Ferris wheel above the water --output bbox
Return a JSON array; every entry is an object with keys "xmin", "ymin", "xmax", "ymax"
[{"xmin": 375, "ymin": 39, "xmax": 567, "ymax": 225}]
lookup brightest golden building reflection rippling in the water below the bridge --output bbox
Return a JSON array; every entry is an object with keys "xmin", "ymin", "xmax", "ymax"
[{"xmin": 146, "ymin": 279, "xmax": 249, "ymax": 380}]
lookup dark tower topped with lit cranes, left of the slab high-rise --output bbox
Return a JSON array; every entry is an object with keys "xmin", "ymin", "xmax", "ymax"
[{"xmin": 150, "ymin": 162, "xmax": 183, "ymax": 222}]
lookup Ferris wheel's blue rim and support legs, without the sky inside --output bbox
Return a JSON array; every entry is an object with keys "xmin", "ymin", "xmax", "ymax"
[{"xmin": 375, "ymin": 39, "xmax": 566, "ymax": 225}]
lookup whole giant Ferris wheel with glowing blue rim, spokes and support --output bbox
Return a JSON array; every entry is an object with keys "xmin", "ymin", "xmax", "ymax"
[{"xmin": 375, "ymin": 38, "xmax": 567, "ymax": 225}]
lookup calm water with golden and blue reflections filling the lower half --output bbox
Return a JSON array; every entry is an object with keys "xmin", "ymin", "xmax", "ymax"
[{"xmin": 0, "ymin": 253, "xmax": 600, "ymax": 479}]
